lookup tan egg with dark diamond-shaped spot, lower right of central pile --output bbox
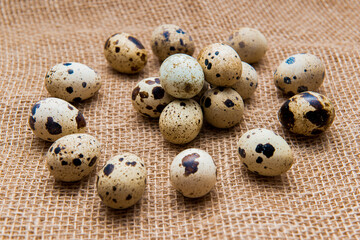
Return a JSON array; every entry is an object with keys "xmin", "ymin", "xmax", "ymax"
[{"xmin": 200, "ymin": 87, "xmax": 244, "ymax": 128}]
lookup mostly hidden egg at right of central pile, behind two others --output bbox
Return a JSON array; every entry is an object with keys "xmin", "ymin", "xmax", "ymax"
[{"xmin": 231, "ymin": 62, "xmax": 258, "ymax": 99}]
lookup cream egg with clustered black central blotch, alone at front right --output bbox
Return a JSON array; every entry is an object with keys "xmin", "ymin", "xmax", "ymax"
[{"xmin": 238, "ymin": 128, "xmax": 293, "ymax": 176}]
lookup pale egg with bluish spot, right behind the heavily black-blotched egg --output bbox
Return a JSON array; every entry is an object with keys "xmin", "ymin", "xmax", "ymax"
[{"xmin": 274, "ymin": 53, "xmax": 325, "ymax": 95}]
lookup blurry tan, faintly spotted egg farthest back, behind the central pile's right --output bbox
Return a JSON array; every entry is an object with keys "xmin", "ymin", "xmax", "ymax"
[{"xmin": 228, "ymin": 28, "xmax": 268, "ymax": 63}]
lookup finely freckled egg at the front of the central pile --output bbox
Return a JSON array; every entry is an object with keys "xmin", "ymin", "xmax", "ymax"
[{"xmin": 159, "ymin": 99, "xmax": 203, "ymax": 144}]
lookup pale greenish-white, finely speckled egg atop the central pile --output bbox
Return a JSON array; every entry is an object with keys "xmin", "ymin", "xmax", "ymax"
[{"xmin": 160, "ymin": 53, "xmax": 204, "ymax": 98}]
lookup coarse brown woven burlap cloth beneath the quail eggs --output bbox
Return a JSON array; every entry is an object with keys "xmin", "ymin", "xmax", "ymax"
[{"xmin": 0, "ymin": 0, "xmax": 360, "ymax": 239}]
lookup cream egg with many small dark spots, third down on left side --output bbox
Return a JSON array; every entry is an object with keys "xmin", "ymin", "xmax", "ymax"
[{"xmin": 46, "ymin": 133, "xmax": 101, "ymax": 182}]
